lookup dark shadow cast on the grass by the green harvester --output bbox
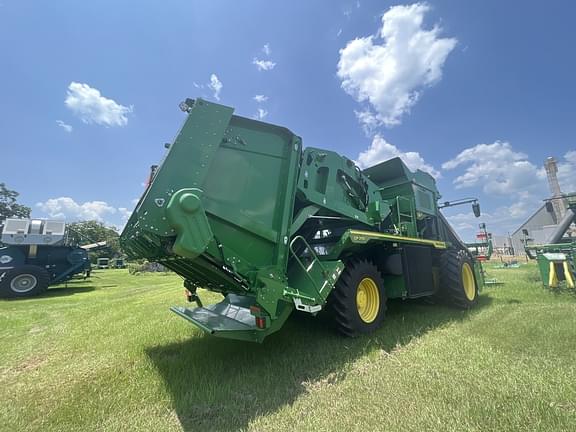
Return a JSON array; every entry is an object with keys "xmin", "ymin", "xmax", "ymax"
[{"xmin": 146, "ymin": 296, "xmax": 492, "ymax": 431}]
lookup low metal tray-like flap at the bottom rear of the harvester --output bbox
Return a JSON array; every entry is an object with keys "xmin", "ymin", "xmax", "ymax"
[{"xmin": 170, "ymin": 294, "xmax": 291, "ymax": 342}]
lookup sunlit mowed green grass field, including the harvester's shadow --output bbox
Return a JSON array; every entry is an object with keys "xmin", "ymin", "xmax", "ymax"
[{"xmin": 0, "ymin": 264, "xmax": 576, "ymax": 432}]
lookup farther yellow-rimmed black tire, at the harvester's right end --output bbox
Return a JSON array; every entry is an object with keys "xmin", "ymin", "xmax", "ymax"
[{"xmin": 435, "ymin": 249, "xmax": 478, "ymax": 309}]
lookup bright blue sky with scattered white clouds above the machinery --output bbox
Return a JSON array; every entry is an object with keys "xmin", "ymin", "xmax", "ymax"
[{"xmin": 0, "ymin": 0, "xmax": 576, "ymax": 238}]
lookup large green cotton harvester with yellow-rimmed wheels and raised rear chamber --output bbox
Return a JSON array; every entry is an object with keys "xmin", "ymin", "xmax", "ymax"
[{"xmin": 120, "ymin": 99, "xmax": 483, "ymax": 342}]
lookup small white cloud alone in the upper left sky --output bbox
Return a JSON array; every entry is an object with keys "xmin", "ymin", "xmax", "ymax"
[{"xmin": 64, "ymin": 82, "xmax": 133, "ymax": 127}]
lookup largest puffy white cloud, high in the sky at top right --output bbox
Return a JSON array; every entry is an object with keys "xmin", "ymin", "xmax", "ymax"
[{"xmin": 337, "ymin": 3, "xmax": 457, "ymax": 127}]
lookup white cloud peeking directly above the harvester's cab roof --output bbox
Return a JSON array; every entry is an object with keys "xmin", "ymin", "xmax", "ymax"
[{"xmin": 356, "ymin": 135, "xmax": 441, "ymax": 178}]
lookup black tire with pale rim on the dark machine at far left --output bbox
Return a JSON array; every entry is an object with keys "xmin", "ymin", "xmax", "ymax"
[{"xmin": 0, "ymin": 265, "xmax": 50, "ymax": 298}]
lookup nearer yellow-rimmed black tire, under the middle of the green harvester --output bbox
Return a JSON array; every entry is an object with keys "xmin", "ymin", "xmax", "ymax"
[{"xmin": 327, "ymin": 259, "xmax": 386, "ymax": 337}]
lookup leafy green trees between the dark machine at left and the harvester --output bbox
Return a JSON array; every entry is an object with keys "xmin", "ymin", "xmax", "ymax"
[{"xmin": 68, "ymin": 220, "xmax": 122, "ymax": 260}]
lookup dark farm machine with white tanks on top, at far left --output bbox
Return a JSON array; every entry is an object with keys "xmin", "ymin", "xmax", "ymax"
[{"xmin": 0, "ymin": 219, "xmax": 106, "ymax": 297}]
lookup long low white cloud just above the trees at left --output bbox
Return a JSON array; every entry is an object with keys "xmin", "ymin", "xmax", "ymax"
[{"xmin": 36, "ymin": 197, "xmax": 117, "ymax": 221}]
